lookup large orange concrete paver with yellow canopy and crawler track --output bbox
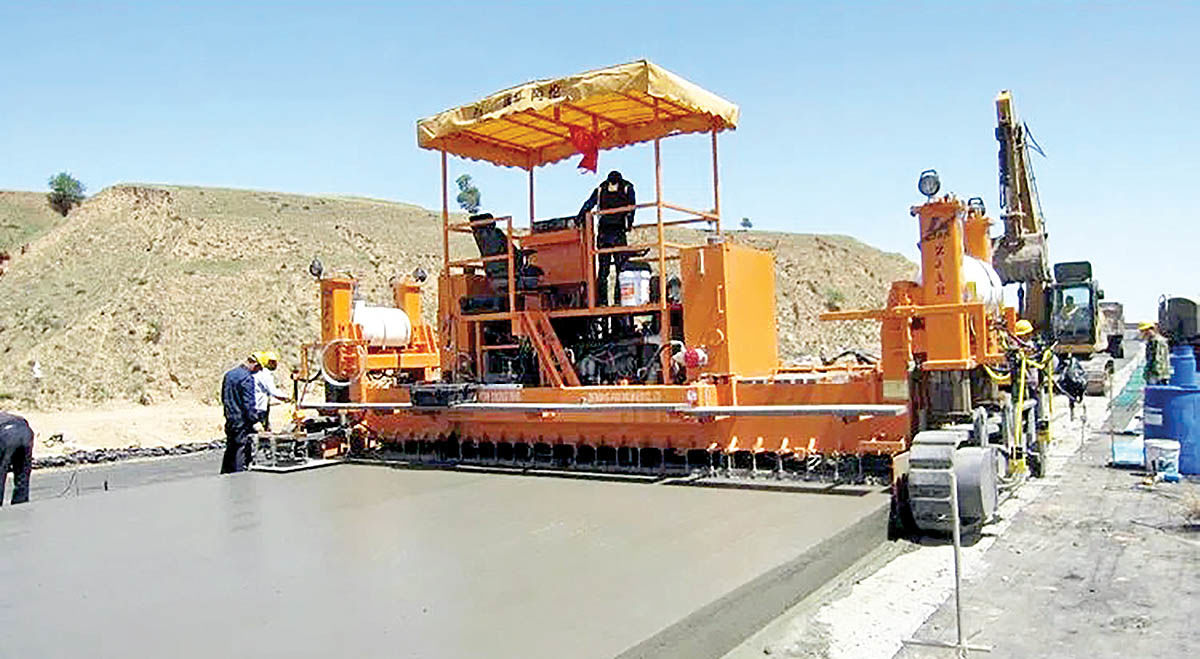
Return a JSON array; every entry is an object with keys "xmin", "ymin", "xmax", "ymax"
[{"xmin": 292, "ymin": 60, "xmax": 1051, "ymax": 528}]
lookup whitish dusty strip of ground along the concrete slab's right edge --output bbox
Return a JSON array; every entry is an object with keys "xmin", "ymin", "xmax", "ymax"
[{"xmin": 727, "ymin": 352, "xmax": 1142, "ymax": 659}]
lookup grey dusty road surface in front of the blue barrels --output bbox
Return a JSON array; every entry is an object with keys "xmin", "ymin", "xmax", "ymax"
[{"xmin": 896, "ymin": 367, "xmax": 1200, "ymax": 659}]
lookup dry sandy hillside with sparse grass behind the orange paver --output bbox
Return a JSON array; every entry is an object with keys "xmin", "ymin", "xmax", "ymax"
[{"xmin": 0, "ymin": 185, "xmax": 914, "ymax": 408}]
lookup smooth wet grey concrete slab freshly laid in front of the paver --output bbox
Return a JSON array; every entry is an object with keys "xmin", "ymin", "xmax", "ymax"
[{"xmin": 0, "ymin": 466, "xmax": 888, "ymax": 658}]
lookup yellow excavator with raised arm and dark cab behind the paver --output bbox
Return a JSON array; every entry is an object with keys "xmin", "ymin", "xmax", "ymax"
[{"xmin": 992, "ymin": 90, "xmax": 1121, "ymax": 395}]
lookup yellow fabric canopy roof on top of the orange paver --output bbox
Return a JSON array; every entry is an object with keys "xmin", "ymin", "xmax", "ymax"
[{"xmin": 416, "ymin": 60, "xmax": 738, "ymax": 169}]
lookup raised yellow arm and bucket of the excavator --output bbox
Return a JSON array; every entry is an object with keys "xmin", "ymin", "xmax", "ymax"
[{"xmin": 992, "ymin": 90, "xmax": 1054, "ymax": 330}]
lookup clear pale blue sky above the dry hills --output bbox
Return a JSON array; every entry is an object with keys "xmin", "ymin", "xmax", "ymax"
[{"xmin": 0, "ymin": 1, "xmax": 1200, "ymax": 317}]
